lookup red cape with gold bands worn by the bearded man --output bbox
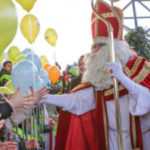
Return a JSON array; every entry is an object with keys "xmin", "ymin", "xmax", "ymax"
[{"xmin": 55, "ymin": 56, "xmax": 150, "ymax": 150}]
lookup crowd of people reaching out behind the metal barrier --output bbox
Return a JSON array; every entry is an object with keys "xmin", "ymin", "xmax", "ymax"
[{"xmin": 0, "ymin": 48, "xmax": 83, "ymax": 150}]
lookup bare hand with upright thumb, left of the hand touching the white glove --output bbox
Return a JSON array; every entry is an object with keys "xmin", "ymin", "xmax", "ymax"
[{"xmin": 10, "ymin": 87, "xmax": 35, "ymax": 108}]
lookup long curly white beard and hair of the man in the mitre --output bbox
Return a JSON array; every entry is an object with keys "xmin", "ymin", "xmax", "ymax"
[{"xmin": 82, "ymin": 39, "xmax": 136, "ymax": 91}]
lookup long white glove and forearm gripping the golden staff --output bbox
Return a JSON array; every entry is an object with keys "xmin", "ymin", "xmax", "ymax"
[{"xmin": 106, "ymin": 62, "xmax": 141, "ymax": 95}]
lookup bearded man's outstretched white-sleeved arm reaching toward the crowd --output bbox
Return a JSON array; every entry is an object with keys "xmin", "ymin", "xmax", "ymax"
[{"xmin": 40, "ymin": 87, "xmax": 95, "ymax": 115}]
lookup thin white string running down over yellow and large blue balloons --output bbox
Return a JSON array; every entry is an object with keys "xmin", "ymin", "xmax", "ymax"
[{"xmin": 29, "ymin": 14, "xmax": 35, "ymax": 89}]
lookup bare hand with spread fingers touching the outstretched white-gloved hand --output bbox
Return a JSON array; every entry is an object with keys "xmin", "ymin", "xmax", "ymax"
[{"xmin": 30, "ymin": 87, "xmax": 49, "ymax": 104}]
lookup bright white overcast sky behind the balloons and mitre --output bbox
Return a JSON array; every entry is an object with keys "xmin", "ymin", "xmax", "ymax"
[{"xmin": 6, "ymin": 0, "xmax": 149, "ymax": 69}]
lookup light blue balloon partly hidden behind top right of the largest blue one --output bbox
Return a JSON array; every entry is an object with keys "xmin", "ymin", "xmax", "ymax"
[{"xmin": 25, "ymin": 53, "xmax": 42, "ymax": 70}]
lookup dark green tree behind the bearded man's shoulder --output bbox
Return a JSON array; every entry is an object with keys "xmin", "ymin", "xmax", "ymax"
[{"xmin": 125, "ymin": 27, "xmax": 150, "ymax": 60}]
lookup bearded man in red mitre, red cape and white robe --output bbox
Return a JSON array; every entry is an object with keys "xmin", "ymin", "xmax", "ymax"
[{"xmin": 32, "ymin": 1, "xmax": 150, "ymax": 150}]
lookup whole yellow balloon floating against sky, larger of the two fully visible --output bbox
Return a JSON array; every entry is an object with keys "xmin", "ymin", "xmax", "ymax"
[{"xmin": 20, "ymin": 15, "xmax": 40, "ymax": 44}]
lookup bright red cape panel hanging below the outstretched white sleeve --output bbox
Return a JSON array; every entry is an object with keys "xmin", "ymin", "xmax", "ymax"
[{"xmin": 65, "ymin": 111, "xmax": 98, "ymax": 150}]
